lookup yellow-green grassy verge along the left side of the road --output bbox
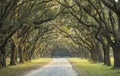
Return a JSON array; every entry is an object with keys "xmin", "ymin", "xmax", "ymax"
[{"xmin": 0, "ymin": 58, "xmax": 51, "ymax": 76}]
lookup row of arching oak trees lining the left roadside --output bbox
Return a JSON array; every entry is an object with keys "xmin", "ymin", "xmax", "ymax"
[{"xmin": 0, "ymin": 0, "xmax": 60, "ymax": 67}]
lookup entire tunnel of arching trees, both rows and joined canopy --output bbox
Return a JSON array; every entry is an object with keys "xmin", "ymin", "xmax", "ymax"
[{"xmin": 0, "ymin": 0, "xmax": 120, "ymax": 68}]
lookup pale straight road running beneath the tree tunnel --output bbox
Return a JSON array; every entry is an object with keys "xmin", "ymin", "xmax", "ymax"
[{"xmin": 24, "ymin": 58, "xmax": 77, "ymax": 76}]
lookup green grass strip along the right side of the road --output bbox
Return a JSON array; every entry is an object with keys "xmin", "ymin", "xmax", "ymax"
[{"xmin": 69, "ymin": 58, "xmax": 120, "ymax": 76}]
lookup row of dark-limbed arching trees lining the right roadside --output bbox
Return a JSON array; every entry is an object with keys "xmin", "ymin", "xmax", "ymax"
[{"xmin": 57, "ymin": 0, "xmax": 120, "ymax": 68}]
